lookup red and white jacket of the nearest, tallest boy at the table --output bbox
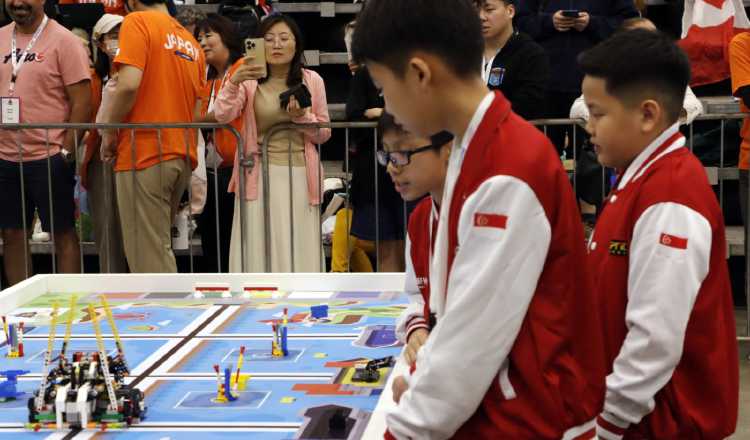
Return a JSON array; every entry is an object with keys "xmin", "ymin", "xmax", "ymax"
[{"xmin": 386, "ymin": 93, "xmax": 605, "ymax": 439}]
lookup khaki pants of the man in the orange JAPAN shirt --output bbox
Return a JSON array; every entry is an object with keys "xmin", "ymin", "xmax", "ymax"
[{"xmin": 115, "ymin": 159, "xmax": 190, "ymax": 273}]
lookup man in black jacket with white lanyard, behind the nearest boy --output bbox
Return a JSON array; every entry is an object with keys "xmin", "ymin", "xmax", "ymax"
[{"xmin": 474, "ymin": 0, "xmax": 550, "ymax": 119}]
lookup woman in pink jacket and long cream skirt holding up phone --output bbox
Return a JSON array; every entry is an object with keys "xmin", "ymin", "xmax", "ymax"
[{"xmin": 214, "ymin": 15, "xmax": 331, "ymax": 272}]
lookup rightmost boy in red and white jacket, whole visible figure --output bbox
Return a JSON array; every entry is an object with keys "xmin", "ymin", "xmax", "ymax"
[{"xmin": 579, "ymin": 29, "xmax": 739, "ymax": 440}]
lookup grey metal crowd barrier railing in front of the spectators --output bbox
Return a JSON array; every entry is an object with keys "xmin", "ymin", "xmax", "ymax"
[{"xmin": 0, "ymin": 113, "xmax": 750, "ymax": 335}]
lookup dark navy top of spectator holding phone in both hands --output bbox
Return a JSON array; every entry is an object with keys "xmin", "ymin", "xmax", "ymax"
[{"xmin": 516, "ymin": 0, "xmax": 638, "ymax": 94}]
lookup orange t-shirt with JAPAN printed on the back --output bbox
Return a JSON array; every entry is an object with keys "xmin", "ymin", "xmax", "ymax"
[{"xmin": 115, "ymin": 11, "xmax": 206, "ymax": 171}]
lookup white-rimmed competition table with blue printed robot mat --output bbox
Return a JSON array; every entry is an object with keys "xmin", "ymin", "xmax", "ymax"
[{"xmin": 0, "ymin": 274, "xmax": 406, "ymax": 440}]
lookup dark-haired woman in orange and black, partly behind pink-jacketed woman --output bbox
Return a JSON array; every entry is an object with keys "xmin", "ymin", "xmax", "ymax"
[{"xmin": 194, "ymin": 14, "xmax": 243, "ymax": 272}]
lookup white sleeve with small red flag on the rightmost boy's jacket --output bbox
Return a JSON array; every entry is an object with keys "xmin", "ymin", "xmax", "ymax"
[{"xmin": 604, "ymin": 203, "xmax": 712, "ymax": 424}]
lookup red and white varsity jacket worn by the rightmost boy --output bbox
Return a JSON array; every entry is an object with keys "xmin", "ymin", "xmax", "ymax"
[{"xmin": 587, "ymin": 124, "xmax": 739, "ymax": 440}]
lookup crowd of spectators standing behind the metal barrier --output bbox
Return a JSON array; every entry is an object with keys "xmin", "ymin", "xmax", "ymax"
[{"xmin": 0, "ymin": 0, "xmax": 747, "ymax": 284}]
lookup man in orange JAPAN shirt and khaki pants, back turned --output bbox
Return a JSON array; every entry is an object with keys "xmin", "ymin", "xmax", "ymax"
[{"xmin": 102, "ymin": 0, "xmax": 205, "ymax": 273}]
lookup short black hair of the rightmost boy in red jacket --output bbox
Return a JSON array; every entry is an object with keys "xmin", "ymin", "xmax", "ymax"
[{"xmin": 578, "ymin": 29, "xmax": 690, "ymax": 122}]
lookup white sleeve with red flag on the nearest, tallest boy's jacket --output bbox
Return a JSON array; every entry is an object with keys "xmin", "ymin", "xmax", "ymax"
[{"xmin": 386, "ymin": 176, "xmax": 551, "ymax": 439}]
